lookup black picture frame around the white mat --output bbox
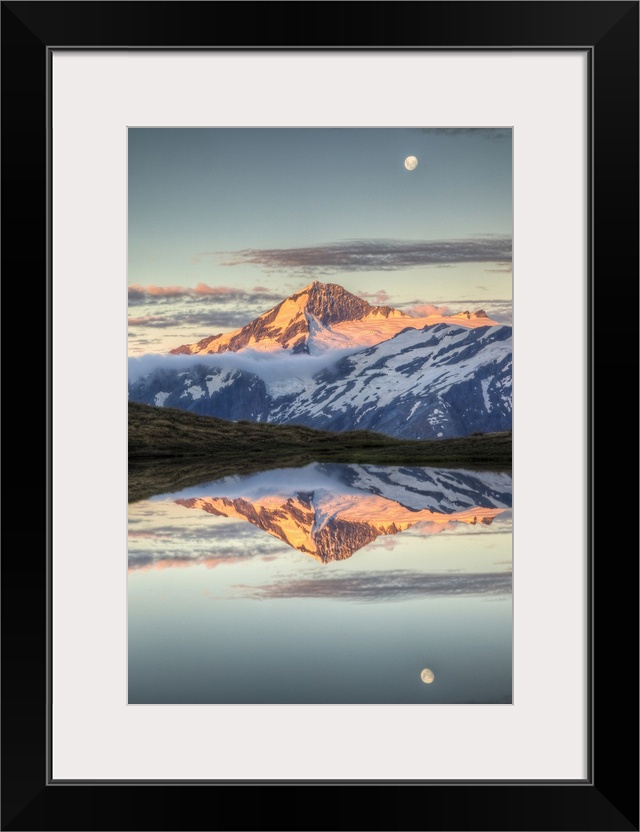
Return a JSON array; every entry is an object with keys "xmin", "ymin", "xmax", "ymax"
[{"xmin": 2, "ymin": 0, "xmax": 639, "ymax": 830}]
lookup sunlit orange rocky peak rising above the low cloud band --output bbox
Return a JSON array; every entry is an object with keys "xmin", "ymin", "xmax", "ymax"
[{"xmin": 171, "ymin": 280, "xmax": 495, "ymax": 355}]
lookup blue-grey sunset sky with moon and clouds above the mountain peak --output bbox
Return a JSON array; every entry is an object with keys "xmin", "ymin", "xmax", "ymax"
[{"xmin": 128, "ymin": 127, "xmax": 512, "ymax": 356}]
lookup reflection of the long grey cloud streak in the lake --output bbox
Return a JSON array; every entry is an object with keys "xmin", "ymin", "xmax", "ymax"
[{"xmin": 237, "ymin": 569, "xmax": 511, "ymax": 602}]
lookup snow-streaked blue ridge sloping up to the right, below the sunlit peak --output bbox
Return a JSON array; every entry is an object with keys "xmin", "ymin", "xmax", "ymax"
[{"xmin": 268, "ymin": 324, "xmax": 512, "ymax": 439}]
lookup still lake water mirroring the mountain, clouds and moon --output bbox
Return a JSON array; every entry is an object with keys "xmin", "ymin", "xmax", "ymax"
[{"xmin": 128, "ymin": 464, "xmax": 512, "ymax": 705}]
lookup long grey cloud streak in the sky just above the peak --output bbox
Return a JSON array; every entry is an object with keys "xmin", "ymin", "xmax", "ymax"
[{"xmin": 223, "ymin": 235, "xmax": 512, "ymax": 274}]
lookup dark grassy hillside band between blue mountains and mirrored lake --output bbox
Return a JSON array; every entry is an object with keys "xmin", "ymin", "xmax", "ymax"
[{"xmin": 129, "ymin": 402, "xmax": 511, "ymax": 502}]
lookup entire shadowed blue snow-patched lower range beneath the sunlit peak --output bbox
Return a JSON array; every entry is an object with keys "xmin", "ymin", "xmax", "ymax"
[{"xmin": 129, "ymin": 318, "xmax": 512, "ymax": 439}]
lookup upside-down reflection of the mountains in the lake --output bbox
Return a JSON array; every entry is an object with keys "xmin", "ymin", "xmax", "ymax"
[{"xmin": 175, "ymin": 464, "xmax": 512, "ymax": 563}]
